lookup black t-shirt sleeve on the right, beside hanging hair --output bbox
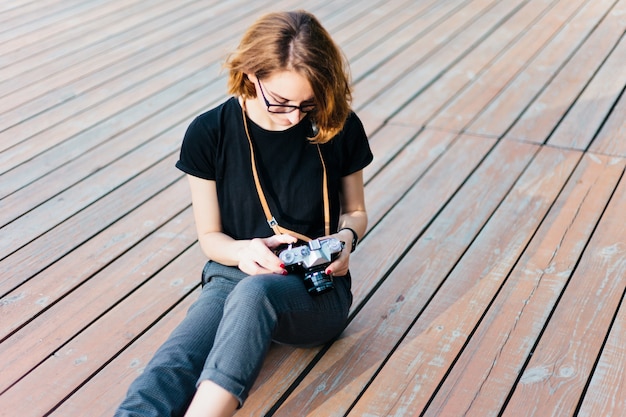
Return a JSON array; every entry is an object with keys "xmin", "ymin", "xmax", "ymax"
[{"xmin": 341, "ymin": 113, "xmax": 374, "ymax": 177}]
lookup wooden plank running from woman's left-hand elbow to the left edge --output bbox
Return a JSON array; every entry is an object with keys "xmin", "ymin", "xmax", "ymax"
[{"xmin": 0, "ymin": 202, "xmax": 198, "ymax": 391}]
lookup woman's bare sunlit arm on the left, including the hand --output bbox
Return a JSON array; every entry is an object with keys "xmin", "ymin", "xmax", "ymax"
[{"xmin": 187, "ymin": 175, "xmax": 296, "ymax": 275}]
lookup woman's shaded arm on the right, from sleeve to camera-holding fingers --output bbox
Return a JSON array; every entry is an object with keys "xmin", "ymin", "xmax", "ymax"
[{"xmin": 327, "ymin": 170, "xmax": 367, "ymax": 276}]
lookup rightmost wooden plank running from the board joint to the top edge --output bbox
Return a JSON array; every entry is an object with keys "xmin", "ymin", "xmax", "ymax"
[{"xmin": 466, "ymin": 0, "xmax": 619, "ymax": 137}]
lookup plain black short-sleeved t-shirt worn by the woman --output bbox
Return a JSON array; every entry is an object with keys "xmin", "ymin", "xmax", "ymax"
[{"xmin": 176, "ymin": 97, "xmax": 373, "ymax": 239}]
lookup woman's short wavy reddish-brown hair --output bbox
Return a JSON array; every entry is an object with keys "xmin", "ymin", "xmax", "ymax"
[{"xmin": 225, "ymin": 10, "xmax": 352, "ymax": 143}]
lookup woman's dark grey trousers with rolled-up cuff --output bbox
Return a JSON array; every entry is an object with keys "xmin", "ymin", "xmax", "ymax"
[{"xmin": 115, "ymin": 262, "xmax": 352, "ymax": 417}]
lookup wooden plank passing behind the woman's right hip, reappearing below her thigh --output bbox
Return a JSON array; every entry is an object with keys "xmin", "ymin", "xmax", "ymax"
[{"xmin": 234, "ymin": 133, "xmax": 493, "ymax": 416}]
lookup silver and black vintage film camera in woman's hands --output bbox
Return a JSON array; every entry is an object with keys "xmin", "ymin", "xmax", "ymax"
[{"xmin": 278, "ymin": 237, "xmax": 344, "ymax": 295}]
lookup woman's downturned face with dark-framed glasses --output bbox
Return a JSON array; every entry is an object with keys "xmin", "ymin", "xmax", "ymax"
[{"xmin": 248, "ymin": 71, "xmax": 315, "ymax": 130}]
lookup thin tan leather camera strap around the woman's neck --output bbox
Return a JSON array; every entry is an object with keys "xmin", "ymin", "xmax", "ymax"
[{"xmin": 241, "ymin": 102, "xmax": 330, "ymax": 242}]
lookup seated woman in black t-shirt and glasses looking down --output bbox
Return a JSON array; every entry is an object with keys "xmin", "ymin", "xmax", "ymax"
[{"xmin": 116, "ymin": 11, "xmax": 372, "ymax": 417}]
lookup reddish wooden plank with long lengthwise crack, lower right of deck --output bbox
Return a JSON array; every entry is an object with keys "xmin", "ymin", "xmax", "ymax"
[{"xmin": 424, "ymin": 155, "xmax": 625, "ymax": 417}]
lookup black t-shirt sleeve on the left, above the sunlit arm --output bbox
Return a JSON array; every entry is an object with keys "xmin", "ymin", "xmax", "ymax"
[{"xmin": 176, "ymin": 115, "xmax": 217, "ymax": 180}]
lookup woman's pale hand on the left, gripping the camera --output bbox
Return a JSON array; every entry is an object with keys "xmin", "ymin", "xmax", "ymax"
[{"xmin": 237, "ymin": 235, "xmax": 297, "ymax": 275}]
